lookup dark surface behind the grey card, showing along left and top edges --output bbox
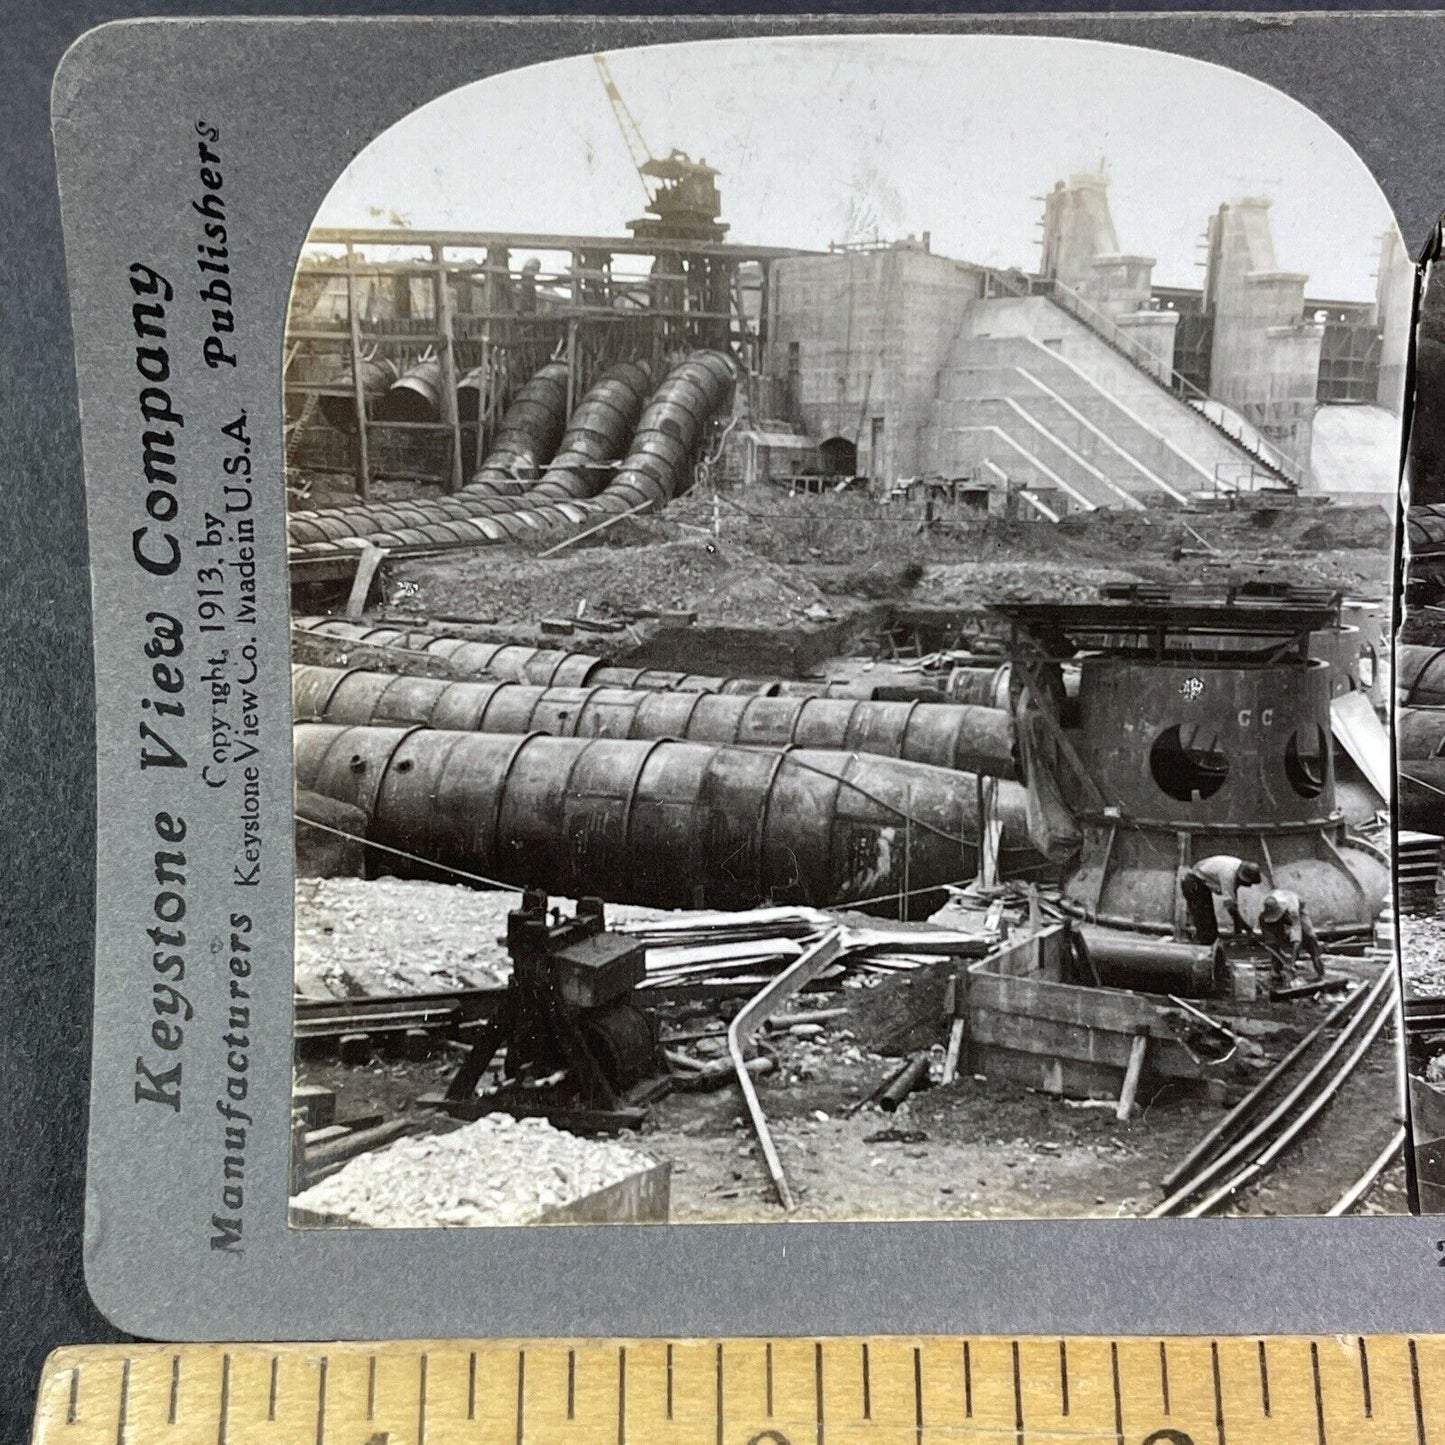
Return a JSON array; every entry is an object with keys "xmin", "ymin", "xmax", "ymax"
[{"xmin": 0, "ymin": 0, "xmax": 1445, "ymax": 1445}]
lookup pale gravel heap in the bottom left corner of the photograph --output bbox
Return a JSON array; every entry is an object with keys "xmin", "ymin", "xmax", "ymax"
[{"xmin": 292, "ymin": 1114, "xmax": 656, "ymax": 1230}]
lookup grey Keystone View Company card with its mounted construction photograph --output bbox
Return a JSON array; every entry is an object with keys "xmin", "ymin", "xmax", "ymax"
[{"xmin": 53, "ymin": 14, "xmax": 1445, "ymax": 1338}]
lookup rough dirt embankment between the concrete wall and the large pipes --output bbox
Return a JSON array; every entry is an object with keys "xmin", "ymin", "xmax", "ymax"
[{"xmin": 387, "ymin": 490, "xmax": 1392, "ymax": 629}]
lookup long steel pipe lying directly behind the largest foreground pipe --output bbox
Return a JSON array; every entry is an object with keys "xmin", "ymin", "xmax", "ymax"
[{"xmin": 292, "ymin": 666, "xmax": 1019, "ymax": 780}]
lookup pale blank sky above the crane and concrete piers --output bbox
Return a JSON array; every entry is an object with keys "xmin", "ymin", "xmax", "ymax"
[{"xmin": 316, "ymin": 36, "xmax": 1394, "ymax": 299}]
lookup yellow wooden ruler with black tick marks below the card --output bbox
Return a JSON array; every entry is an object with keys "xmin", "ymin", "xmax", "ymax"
[{"xmin": 35, "ymin": 1335, "xmax": 1445, "ymax": 1445}]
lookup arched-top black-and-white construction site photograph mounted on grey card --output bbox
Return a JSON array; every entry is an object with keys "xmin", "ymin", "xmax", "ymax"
[{"xmin": 283, "ymin": 36, "xmax": 1410, "ymax": 1228}]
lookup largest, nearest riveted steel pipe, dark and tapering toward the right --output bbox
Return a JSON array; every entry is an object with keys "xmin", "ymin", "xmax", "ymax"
[{"xmin": 295, "ymin": 723, "xmax": 1039, "ymax": 916}]
